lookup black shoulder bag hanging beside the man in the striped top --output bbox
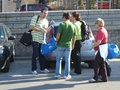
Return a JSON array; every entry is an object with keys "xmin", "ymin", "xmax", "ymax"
[{"xmin": 20, "ymin": 30, "xmax": 32, "ymax": 46}]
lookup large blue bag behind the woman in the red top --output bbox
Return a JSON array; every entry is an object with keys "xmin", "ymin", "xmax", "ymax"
[{"xmin": 107, "ymin": 43, "xmax": 120, "ymax": 59}]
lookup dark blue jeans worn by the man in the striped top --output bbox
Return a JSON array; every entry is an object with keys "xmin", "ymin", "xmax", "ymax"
[{"xmin": 32, "ymin": 42, "xmax": 46, "ymax": 71}]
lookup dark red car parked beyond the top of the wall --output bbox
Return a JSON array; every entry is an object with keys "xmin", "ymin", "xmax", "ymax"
[{"xmin": 20, "ymin": 4, "xmax": 52, "ymax": 12}]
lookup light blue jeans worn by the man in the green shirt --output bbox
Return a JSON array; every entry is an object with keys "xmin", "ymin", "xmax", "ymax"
[{"xmin": 56, "ymin": 47, "xmax": 71, "ymax": 76}]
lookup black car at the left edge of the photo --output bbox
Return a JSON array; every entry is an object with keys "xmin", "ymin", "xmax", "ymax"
[{"xmin": 0, "ymin": 23, "xmax": 15, "ymax": 72}]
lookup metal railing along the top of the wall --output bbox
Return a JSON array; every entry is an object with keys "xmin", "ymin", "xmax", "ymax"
[{"xmin": 47, "ymin": 0, "xmax": 120, "ymax": 10}]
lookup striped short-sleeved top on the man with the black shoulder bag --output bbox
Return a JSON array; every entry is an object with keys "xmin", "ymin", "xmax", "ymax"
[{"xmin": 30, "ymin": 15, "xmax": 49, "ymax": 43}]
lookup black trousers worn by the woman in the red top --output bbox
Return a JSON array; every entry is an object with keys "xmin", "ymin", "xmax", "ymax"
[{"xmin": 93, "ymin": 51, "xmax": 108, "ymax": 82}]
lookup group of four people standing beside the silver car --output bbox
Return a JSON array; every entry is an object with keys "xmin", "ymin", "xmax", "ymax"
[{"xmin": 30, "ymin": 8, "xmax": 108, "ymax": 82}]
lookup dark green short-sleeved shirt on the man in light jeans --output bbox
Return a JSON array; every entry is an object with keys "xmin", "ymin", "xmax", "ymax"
[{"xmin": 58, "ymin": 21, "xmax": 76, "ymax": 48}]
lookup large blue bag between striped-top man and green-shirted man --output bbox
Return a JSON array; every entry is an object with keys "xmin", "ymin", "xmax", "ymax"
[{"xmin": 40, "ymin": 37, "xmax": 57, "ymax": 55}]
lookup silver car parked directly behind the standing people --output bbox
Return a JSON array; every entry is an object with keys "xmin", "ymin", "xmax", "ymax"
[{"xmin": 46, "ymin": 22, "xmax": 95, "ymax": 67}]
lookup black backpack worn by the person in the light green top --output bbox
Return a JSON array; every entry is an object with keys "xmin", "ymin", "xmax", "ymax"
[{"xmin": 80, "ymin": 20, "xmax": 88, "ymax": 42}]
